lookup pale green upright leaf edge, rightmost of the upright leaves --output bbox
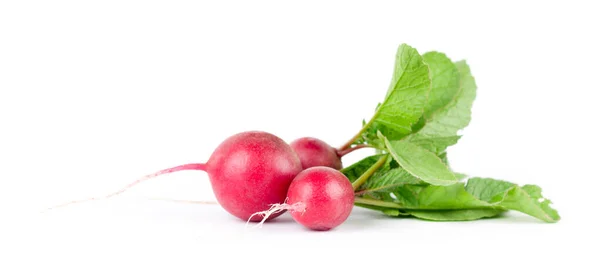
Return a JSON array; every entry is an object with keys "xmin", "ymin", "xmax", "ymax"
[{"xmin": 406, "ymin": 61, "xmax": 477, "ymax": 153}]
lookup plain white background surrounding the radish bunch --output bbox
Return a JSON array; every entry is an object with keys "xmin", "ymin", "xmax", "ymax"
[{"xmin": 0, "ymin": 1, "xmax": 600, "ymax": 276}]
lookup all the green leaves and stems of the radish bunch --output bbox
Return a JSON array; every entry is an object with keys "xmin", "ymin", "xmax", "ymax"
[{"xmin": 339, "ymin": 44, "xmax": 560, "ymax": 222}]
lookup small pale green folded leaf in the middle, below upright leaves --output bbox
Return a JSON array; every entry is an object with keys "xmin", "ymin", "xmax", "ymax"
[{"xmin": 383, "ymin": 137, "xmax": 457, "ymax": 186}]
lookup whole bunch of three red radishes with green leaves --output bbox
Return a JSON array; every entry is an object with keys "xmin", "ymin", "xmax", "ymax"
[{"xmin": 48, "ymin": 44, "xmax": 560, "ymax": 230}]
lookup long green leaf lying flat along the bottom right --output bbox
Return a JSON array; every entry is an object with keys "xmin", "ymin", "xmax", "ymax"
[{"xmin": 357, "ymin": 178, "xmax": 560, "ymax": 222}]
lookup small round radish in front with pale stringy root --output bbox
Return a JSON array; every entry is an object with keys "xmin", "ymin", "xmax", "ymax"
[{"xmin": 252, "ymin": 166, "xmax": 354, "ymax": 231}]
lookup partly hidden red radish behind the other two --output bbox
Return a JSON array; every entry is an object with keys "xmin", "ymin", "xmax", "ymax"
[{"xmin": 290, "ymin": 137, "xmax": 366, "ymax": 170}]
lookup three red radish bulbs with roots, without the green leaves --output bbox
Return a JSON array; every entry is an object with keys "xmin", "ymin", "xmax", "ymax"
[{"xmin": 50, "ymin": 131, "xmax": 354, "ymax": 230}]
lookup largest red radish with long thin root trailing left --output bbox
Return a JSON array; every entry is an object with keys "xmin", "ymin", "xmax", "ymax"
[{"xmin": 48, "ymin": 131, "xmax": 302, "ymax": 221}]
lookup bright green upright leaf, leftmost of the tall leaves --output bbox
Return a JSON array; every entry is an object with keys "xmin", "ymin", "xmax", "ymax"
[{"xmin": 361, "ymin": 44, "xmax": 431, "ymax": 140}]
